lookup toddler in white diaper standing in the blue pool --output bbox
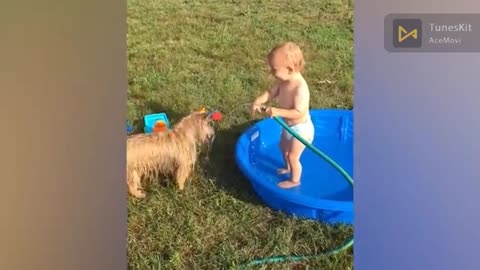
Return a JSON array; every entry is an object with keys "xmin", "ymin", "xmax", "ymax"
[{"xmin": 251, "ymin": 42, "xmax": 314, "ymax": 188}]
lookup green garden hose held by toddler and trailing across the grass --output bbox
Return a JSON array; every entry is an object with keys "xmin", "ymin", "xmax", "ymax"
[{"xmin": 240, "ymin": 116, "xmax": 353, "ymax": 269}]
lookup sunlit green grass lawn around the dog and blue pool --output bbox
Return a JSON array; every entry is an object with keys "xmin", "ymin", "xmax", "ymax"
[{"xmin": 127, "ymin": 0, "xmax": 353, "ymax": 270}]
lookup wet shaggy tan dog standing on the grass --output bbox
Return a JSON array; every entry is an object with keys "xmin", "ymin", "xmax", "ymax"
[{"xmin": 127, "ymin": 112, "xmax": 215, "ymax": 198}]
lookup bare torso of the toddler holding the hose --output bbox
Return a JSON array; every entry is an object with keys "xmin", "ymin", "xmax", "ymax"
[{"xmin": 275, "ymin": 77, "xmax": 310, "ymax": 126}]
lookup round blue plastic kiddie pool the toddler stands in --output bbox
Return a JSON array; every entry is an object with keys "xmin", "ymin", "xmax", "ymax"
[{"xmin": 235, "ymin": 110, "xmax": 354, "ymax": 224}]
